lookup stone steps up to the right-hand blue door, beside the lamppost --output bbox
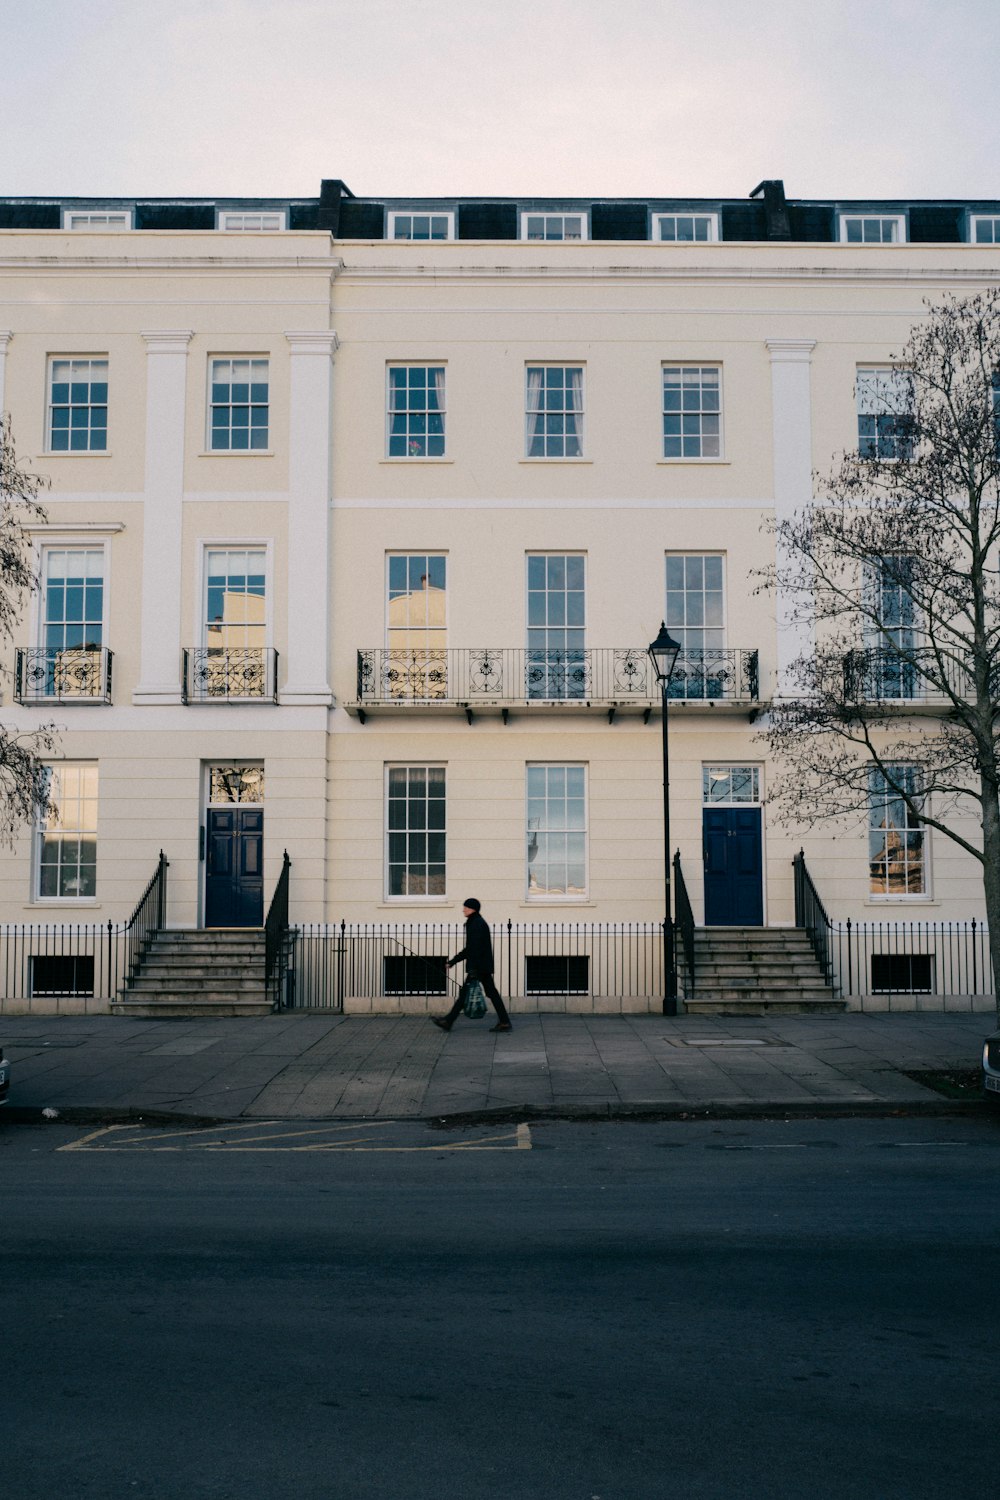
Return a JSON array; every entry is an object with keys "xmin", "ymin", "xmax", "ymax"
[{"xmin": 684, "ymin": 927, "xmax": 847, "ymax": 1016}]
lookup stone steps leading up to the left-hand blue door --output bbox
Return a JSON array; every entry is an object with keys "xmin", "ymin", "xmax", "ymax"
[{"xmin": 111, "ymin": 927, "xmax": 271, "ymax": 1017}]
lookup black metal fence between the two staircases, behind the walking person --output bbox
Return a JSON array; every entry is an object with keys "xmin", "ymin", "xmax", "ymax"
[{"xmin": 285, "ymin": 920, "xmax": 663, "ymax": 1010}]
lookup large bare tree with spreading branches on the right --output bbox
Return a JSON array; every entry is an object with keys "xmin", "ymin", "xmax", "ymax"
[{"xmin": 763, "ymin": 290, "xmax": 1000, "ymax": 1005}]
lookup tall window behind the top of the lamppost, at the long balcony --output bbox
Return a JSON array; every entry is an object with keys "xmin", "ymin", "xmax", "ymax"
[{"xmin": 666, "ymin": 552, "xmax": 726, "ymax": 698}]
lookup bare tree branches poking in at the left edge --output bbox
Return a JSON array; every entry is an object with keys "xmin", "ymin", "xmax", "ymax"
[{"xmin": 0, "ymin": 417, "xmax": 55, "ymax": 845}]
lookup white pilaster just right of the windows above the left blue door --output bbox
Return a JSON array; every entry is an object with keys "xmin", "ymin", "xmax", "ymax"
[{"xmin": 280, "ymin": 330, "xmax": 339, "ymax": 705}]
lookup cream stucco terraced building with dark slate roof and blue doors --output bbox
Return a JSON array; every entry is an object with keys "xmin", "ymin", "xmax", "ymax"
[{"xmin": 0, "ymin": 182, "xmax": 1000, "ymax": 1014}]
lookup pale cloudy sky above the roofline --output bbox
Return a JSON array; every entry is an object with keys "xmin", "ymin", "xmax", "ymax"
[{"xmin": 0, "ymin": 0, "xmax": 1000, "ymax": 198}]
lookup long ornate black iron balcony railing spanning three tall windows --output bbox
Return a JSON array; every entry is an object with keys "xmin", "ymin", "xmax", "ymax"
[{"xmin": 357, "ymin": 647, "xmax": 760, "ymax": 708}]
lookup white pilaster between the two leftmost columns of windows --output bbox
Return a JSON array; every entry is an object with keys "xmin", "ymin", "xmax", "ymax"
[{"xmin": 132, "ymin": 330, "xmax": 193, "ymax": 704}]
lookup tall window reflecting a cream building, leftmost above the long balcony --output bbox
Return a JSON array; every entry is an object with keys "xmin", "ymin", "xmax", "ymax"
[{"xmin": 385, "ymin": 552, "xmax": 448, "ymax": 698}]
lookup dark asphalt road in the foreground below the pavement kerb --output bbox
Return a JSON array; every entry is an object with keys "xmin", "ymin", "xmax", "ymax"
[{"xmin": 0, "ymin": 1119, "xmax": 1000, "ymax": 1500}]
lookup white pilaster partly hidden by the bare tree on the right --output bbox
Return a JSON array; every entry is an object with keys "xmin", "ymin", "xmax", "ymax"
[{"xmin": 766, "ymin": 339, "xmax": 816, "ymax": 698}]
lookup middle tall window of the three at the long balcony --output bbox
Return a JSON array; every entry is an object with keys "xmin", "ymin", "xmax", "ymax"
[{"xmin": 525, "ymin": 552, "xmax": 588, "ymax": 699}]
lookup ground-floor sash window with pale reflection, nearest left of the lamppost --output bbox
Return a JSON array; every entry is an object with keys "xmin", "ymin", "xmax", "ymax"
[{"xmin": 526, "ymin": 765, "xmax": 586, "ymax": 897}]
